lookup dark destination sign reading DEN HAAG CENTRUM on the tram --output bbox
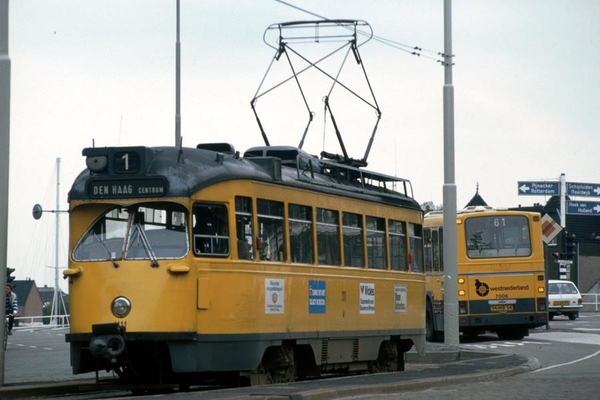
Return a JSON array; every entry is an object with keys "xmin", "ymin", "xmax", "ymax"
[{"xmin": 87, "ymin": 178, "xmax": 167, "ymax": 199}]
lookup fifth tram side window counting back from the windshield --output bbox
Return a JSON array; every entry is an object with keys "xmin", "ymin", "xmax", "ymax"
[{"xmin": 317, "ymin": 208, "xmax": 341, "ymax": 265}]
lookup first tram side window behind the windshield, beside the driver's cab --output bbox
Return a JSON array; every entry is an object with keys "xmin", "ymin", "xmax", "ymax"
[{"xmin": 193, "ymin": 204, "xmax": 229, "ymax": 257}]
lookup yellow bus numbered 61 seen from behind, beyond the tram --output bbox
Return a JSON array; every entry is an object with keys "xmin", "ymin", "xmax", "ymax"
[{"xmin": 423, "ymin": 206, "xmax": 548, "ymax": 341}]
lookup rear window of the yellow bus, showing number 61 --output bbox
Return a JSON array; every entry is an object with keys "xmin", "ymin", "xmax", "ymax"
[{"xmin": 465, "ymin": 215, "xmax": 531, "ymax": 258}]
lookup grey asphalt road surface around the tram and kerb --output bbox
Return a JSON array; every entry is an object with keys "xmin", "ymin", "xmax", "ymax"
[{"xmin": 0, "ymin": 313, "xmax": 600, "ymax": 400}]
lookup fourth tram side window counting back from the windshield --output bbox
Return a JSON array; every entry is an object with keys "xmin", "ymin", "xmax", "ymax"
[{"xmin": 288, "ymin": 204, "xmax": 313, "ymax": 264}]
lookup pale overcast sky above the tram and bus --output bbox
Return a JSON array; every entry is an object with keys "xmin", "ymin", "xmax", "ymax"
[{"xmin": 8, "ymin": 0, "xmax": 600, "ymax": 290}]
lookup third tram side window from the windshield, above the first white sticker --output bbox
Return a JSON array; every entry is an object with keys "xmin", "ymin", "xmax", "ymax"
[{"xmin": 256, "ymin": 199, "xmax": 285, "ymax": 261}]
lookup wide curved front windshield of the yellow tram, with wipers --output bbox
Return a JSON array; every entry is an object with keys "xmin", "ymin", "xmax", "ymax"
[{"xmin": 73, "ymin": 203, "xmax": 189, "ymax": 266}]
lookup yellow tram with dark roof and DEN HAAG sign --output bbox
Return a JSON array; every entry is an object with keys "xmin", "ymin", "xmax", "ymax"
[{"xmin": 64, "ymin": 143, "xmax": 425, "ymax": 386}]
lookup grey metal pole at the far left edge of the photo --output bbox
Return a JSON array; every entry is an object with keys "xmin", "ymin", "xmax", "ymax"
[{"xmin": 0, "ymin": 0, "xmax": 10, "ymax": 385}]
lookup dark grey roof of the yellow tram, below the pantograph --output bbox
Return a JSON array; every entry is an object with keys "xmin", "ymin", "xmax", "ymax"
[{"xmin": 69, "ymin": 143, "xmax": 420, "ymax": 209}]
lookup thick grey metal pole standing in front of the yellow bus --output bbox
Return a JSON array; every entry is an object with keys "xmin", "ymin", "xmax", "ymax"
[{"xmin": 444, "ymin": 0, "xmax": 459, "ymax": 350}]
